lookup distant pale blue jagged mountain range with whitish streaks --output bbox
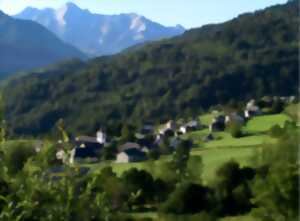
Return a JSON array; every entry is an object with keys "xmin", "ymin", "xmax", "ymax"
[{"xmin": 15, "ymin": 3, "xmax": 184, "ymax": 56}]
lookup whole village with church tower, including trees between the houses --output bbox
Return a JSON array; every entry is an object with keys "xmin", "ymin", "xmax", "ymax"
[{"xmin": 56, "ymin": 96, "xmax": 296, "ymax": 164}]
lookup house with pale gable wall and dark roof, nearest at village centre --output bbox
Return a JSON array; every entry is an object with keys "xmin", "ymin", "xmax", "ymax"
[{"xmin": 116, "ymin": 148, "xmax": 147, "ymax": 163}]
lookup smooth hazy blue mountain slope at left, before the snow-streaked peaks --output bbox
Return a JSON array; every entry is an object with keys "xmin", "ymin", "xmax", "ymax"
[{"xmin": 0, "ymin": 12, "xmax": 85, "ymax": 75}]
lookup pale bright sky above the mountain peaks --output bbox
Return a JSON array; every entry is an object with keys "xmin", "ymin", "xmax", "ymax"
[{"xmin": 0, "ymin": 0, "xmax": 287, "ymax": 28}]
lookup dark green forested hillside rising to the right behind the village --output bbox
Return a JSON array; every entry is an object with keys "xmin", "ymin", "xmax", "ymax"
[{"xmin": 3, "ymin": 1, "xmax": 299, "ymax": 135}]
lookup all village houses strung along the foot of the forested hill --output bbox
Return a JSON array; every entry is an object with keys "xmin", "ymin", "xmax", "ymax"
[{"xmin": 57, "ymin": 97, "xmax": 296, "ymax": 164}]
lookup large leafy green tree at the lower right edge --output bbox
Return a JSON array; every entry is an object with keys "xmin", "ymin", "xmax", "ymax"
[{"xmin": 252, "ymin": 123, "xmax": 300, "ymax": 221}]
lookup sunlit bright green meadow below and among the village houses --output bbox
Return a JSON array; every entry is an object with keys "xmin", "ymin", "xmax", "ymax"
[{"xmin": 90, "ymin": 114, "xmax": 290, "ymax": 182}]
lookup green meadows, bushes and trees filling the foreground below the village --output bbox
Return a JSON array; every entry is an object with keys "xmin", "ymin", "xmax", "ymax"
[{"xmin": 0, "ymin": 108, "xmax": 299, "ymax": 221}]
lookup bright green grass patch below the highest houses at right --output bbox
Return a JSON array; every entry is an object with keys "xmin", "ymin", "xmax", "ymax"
[{"xmin": 245, "ymin": 114, "xmax": 291, "ymax": 133}]
